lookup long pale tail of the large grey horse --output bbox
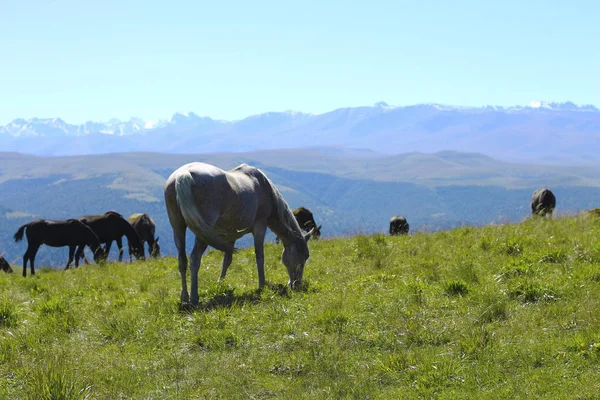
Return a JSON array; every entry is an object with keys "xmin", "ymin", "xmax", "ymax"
[{"xmin": 175, "ymin": 171, "xmax": 236, "ymax": 252}]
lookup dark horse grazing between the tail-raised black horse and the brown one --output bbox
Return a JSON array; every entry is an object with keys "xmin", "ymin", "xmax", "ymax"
[{"xmin": 75, "ymin": 211, "xmax": 144, "ymax": 262}]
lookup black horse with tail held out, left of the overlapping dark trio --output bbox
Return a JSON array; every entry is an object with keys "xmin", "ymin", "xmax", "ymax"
[{"xmin": 14, "ymin": 219, "xmax": 106, "ymax": 276}]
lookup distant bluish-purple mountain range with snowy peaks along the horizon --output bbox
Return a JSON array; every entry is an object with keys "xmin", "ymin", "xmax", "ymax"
[{"xmin": 0, "ymin": 101, "xmax": 600, "ymax": 165}]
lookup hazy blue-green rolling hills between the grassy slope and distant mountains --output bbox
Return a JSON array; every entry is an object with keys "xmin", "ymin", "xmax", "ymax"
[{"xmin": 0, "ymin": 148, "xmax": 600, "ymax": 266}]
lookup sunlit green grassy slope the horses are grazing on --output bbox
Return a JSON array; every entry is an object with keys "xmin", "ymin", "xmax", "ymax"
[{"xmin": 0, "ymin": 214, "xmax": 600, "ymax": 399}]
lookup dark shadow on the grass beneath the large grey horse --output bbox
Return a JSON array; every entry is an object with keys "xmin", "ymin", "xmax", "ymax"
[{"xmin": 179, "ymin": 282, "xmax": 308, "ymax": 313}]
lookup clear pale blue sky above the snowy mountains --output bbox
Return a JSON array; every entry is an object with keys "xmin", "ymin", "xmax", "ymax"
[{"xmin": 0, "ymin": 0, "xmax": 600, "ymax": 124}]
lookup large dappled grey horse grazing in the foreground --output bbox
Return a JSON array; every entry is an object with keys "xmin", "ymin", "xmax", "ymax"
[{"xmin": 165, "ymin": 162, "xmax": 311, "ymax": 305}]
